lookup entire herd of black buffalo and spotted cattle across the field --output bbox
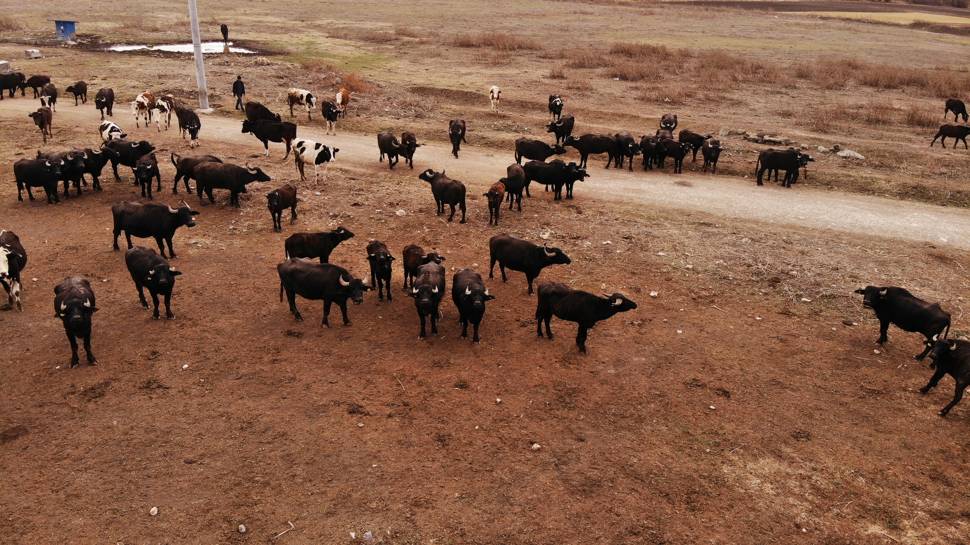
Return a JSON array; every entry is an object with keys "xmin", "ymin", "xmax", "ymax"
[{"xmin": 0, "ymin": 70, "xmax": 970, "ymax": 415}]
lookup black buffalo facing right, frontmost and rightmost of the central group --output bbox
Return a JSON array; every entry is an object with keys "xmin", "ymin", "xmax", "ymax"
[{"xmin": 536, "ymin": 282, "xmax": 637, "ymax": 353}]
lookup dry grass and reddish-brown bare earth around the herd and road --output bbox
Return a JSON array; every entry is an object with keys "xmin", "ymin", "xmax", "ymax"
[{"xmin": 0, "ymin": 0, "xmax": 970, "ymax": 545}]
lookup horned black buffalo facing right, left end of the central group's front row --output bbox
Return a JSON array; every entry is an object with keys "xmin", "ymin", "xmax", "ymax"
[{"xmin": 276, "ymin": 259, "xmax": 372, "ymax": 327}]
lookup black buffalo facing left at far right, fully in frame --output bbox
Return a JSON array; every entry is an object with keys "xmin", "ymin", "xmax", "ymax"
[{"xmin": 855, "ymin": 286, "xmax": 950, "ymax": 360}]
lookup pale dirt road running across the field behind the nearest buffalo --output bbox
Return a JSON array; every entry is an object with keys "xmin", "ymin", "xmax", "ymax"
[{"xmin": 7, "ymin": 100, "xmax": 970, "ymax": 249}]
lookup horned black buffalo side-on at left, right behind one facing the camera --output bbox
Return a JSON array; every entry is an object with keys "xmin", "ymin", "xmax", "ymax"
[{"xmin": 111, "ymin": 201, "xmax": 199, "ymax": 259}]
